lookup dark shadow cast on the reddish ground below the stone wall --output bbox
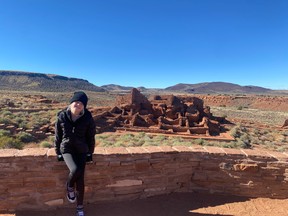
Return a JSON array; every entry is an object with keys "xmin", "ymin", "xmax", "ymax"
[{"xmin": 16, "ymin": 193, "xmax": 250, "ymax": 216}]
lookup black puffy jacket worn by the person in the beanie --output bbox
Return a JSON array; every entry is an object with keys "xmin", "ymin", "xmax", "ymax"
[{"xmin": 54, "ymin": 109, "xmax": 96, "ymax": 155}]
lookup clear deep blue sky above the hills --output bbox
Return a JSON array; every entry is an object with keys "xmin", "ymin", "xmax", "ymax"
[{"xmin": 0, "ymin": 0, "xmax": 288, "ymax": 89}]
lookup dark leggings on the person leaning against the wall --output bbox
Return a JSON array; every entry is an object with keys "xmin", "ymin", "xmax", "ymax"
[{"xmin": 63, "ymin": 153, "xmax": 86, "ymax": 205}]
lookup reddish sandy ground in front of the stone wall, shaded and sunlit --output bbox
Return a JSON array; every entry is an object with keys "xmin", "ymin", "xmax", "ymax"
[{"xmin": 0, "ymin": 193, "xmax": 288, "ymax": 216}]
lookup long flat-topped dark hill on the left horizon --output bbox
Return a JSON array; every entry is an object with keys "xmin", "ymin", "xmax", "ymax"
[{"xmin": 0, "ymin": 70, "xmax": 105, "ymax": 92}]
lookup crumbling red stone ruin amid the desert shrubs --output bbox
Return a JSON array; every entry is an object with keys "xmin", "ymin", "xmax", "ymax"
[{"xmin": 92, "ymin": 88, "xmax": 224, "ymax": 136}]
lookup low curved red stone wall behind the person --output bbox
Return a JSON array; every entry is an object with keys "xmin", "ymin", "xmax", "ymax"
[{"xmin": 0, "ymin": 146, "xmax": 288, "ymax": 212}]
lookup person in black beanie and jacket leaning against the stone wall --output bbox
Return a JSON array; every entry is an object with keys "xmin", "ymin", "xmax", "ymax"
[{"xmin": 54, "ymin": 91, "xmax": 96, "ymax": 216}]
